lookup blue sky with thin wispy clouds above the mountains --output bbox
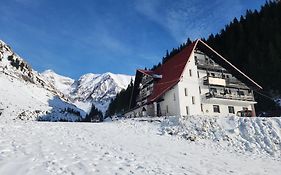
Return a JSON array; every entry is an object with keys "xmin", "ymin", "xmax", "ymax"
[{"xmin": 0, "ymin": 0, "xmax": 265, "ymax": 78}]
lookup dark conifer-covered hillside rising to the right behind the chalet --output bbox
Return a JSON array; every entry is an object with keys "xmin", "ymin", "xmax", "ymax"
[{"xmin": 203, "ymin": 1, "xmax": 281, "ymax": 111}]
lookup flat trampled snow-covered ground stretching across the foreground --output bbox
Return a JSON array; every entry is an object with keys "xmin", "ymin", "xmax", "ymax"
[{"xmin": 0, "ymin": 118, "xmax": 281, "ymax": 175}]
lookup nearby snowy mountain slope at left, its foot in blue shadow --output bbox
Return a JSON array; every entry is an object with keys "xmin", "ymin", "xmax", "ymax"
[{"xmin": 0, "ymin": 40, "xmax": 85, "ymax": 121}]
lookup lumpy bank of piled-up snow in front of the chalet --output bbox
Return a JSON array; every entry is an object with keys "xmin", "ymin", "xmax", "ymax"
[{"xmin": 160, "ymin": 116, "xmax": 281, "ymax": 157}]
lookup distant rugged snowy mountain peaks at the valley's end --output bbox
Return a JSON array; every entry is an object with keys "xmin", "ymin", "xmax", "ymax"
[{"xmin": 41, "ymin": 70, "xmax": 133, "ymax": 112}]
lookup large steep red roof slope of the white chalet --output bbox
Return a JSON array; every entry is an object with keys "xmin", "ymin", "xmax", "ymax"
[{"xmin": 148, "ymin": 41, "xmax": 198, "ymax": 102}]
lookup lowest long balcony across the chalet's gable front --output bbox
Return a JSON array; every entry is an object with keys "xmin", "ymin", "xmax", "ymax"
[{"xmin": 205, "ymin": 92, "xmax": 255, "ymax": 101}]
